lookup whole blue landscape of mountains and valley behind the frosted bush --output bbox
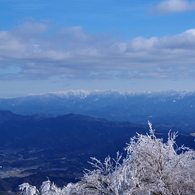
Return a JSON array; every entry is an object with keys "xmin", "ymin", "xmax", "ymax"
[{"xmin": 0, "ymin": 91, "xmax": 195, "ymax": 195}]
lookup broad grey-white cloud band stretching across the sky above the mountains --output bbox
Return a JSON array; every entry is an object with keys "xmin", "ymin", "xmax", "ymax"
[{"xmin": 0, "ymin": 22, "xmax": 195, "ymax": 80}]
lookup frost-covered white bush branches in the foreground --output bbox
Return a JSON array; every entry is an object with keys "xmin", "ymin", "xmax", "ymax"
[{"xmin": 19, "ymin": 122, "xmax": 195, "ymax": 195}]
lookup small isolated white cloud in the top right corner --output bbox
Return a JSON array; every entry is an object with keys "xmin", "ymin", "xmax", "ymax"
[{"xmin": 152, "ymin": 0, "xmax": 195, "ymax": 14}]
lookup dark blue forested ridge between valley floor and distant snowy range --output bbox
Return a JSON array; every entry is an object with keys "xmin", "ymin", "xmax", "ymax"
[{"xmin": 0, "ymin": 111, "xmax": 193, "ymax": 150}]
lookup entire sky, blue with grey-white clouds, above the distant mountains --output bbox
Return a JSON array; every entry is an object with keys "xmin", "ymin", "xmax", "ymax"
[{"xmin": 0, "ymin": 0, "xmax": 195, "ymax": 97}]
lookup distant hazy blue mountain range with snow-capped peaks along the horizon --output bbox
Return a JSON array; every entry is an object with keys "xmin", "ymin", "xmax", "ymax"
[{"xmin": 0, "ymin": 90, "xmax": 195, "ymax": 129}]
